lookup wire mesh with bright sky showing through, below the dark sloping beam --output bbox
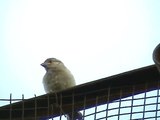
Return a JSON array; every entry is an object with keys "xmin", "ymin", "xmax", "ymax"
[{"xmin": 84, "ymin": 90, "xmax": 160, "ymax": 120}]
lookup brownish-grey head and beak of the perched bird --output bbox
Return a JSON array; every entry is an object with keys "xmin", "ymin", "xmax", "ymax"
[{"xmin": 41, "ymin": 58, "xmax": 64, "ymax": 70}]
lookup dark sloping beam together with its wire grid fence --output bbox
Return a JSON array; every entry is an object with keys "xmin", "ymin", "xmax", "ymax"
[{"xmin": 0, "ymin": 65, "xmax": 160, "ymax": 120}]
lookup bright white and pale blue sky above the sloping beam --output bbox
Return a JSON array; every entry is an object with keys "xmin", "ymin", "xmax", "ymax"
[{"xmin": 0, "ymin": 0, "xmax": 160, "ymax": 102}]
